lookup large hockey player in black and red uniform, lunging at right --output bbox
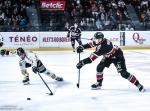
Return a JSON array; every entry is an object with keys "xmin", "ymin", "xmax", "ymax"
[{"xmin": 76, "ymin": 32, "xmax": 145, "ymax": 92}]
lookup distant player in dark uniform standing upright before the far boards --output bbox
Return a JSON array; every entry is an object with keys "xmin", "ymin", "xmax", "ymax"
[{"xmin": 67, "ymin": 23, "xmax": 82, "ymax": 52}]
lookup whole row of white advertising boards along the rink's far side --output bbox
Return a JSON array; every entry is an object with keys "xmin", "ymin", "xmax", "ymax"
[{"xmin": 0, "ymin": 31, "xmax": 150, "ymax": 48}]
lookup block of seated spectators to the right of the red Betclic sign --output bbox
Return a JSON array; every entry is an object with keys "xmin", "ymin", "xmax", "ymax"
[{"xmin": 66, "ymin": 0, "xmax": 150, "ymax": 30}]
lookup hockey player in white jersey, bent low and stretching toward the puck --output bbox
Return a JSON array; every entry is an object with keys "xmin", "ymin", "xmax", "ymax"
[{"xmin": 17, "ymin": 47, "xmax": 63, "ymax": 85}]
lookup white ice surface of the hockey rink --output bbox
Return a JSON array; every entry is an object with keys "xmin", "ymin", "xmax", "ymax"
[{"xmin": 0, "ymin": 50, "xmax": 150, "ymax": 111}]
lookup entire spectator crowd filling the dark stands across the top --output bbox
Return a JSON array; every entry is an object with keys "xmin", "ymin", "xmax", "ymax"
[{"xmin": 0, "ymin": 0, "xmax": 150, "ymax": 31}]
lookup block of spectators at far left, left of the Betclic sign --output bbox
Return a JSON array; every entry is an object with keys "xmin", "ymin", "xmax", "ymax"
[{"xmin": 0, "ymin": 0, "xmax": 31, "ymax": 31}]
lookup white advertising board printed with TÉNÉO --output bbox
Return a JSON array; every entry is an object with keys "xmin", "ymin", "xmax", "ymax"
[{"xmin": 0, "ymin": 32, "xmax": 40, "ymax": 48}]
